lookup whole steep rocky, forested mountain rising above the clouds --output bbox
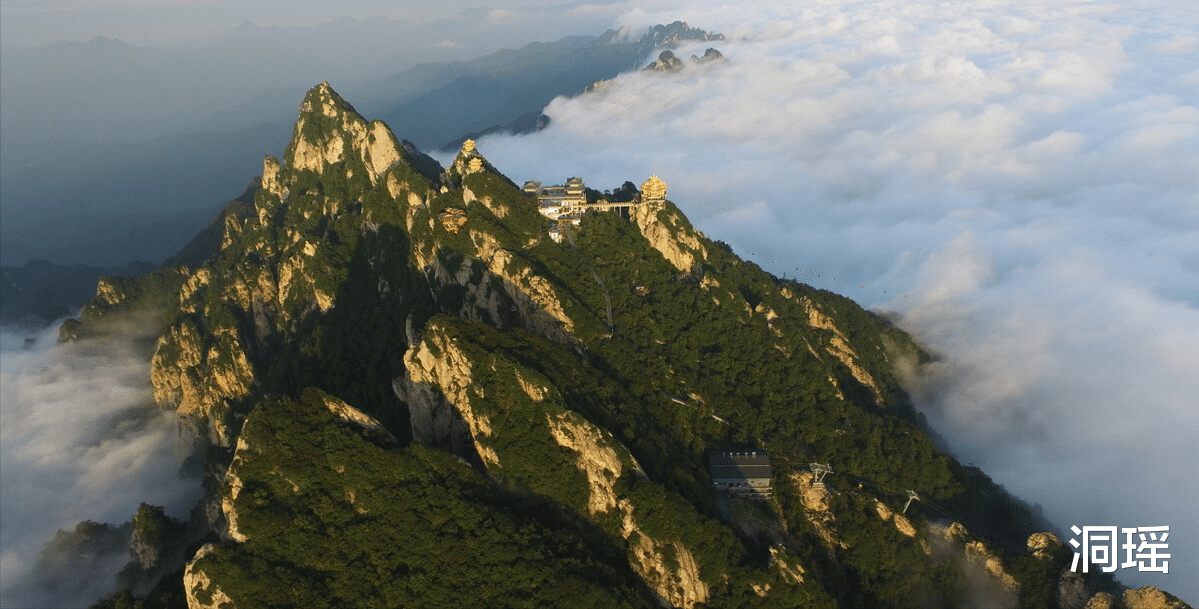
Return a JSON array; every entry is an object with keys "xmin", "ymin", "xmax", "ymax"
[{"xmin": 76, "ymin": 84, "xmax": 1189, "ymax": 608}]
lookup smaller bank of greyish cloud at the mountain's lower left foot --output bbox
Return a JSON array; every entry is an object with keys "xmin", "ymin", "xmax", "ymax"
[{"xmin": 0, "ymin": 324, "xmax": 201, "ymax": 608}]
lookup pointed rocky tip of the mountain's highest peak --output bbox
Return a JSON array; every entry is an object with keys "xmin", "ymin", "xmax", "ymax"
[{"xmin": 284, "ymin": 82, "xmax": 404, "ymax": 183}]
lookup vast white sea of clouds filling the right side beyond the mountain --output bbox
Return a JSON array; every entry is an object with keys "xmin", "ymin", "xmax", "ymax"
[{"xmin": 453, "ymin": 0, "xmax": 1199, "ymax": 603}]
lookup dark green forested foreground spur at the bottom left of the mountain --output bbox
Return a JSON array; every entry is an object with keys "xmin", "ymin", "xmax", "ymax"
[{"xmin": 191, "ymin": 390, "xmax": 655, "ymax": 608}]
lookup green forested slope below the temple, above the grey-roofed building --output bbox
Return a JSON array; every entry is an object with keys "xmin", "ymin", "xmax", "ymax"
[{"xmin": 529, "ymin": 207, "xmax": 960, "ymax": 496}]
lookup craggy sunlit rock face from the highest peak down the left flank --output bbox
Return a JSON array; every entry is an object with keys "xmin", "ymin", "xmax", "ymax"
[{"xmin": 151, "ymin": 83, "xmax": 441, "ymax": 447}]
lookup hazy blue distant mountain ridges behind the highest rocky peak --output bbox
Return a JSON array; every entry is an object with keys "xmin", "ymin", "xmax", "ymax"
[{"xmin": 0, "ymin": 22, "xmax": 723, "ymax": 320}]
